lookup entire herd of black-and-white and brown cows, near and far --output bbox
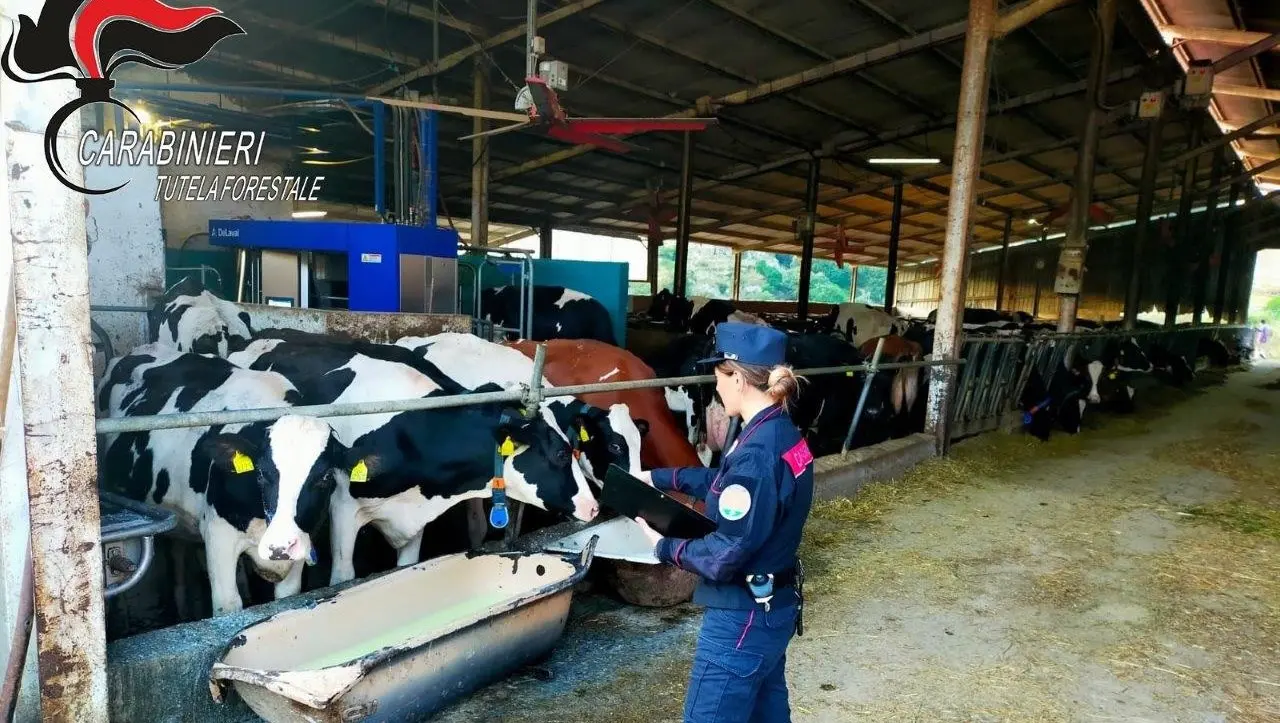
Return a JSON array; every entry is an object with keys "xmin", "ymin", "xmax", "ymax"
[{"xmin": 97, "ymin": 280, "xmax": 1244, "ymax": 614}]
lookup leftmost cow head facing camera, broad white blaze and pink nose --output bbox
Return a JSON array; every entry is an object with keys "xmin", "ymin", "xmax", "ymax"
[{"xmin": 202, "ymin": 415, "xmax": 346, "ymax": 562}]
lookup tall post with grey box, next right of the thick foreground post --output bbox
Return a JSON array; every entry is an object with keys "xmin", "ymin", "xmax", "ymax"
[{"xmin": 1053, "ymin": 0, "xmax": 1117, "ymax": 331}]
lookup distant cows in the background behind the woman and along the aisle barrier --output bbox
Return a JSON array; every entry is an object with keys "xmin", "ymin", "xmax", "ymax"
[{"xmin": 628, "ymin": 289, "xmax": 1242, "ymax": 447}]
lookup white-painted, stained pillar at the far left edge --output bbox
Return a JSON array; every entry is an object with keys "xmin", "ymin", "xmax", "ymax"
[{"xmin": 0, "ymin": 55, "xmax": 108, "ymax": 723}]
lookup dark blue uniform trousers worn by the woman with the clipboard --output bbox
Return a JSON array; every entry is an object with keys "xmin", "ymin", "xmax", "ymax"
[{"xmin": 685, "ymin": 605, "xmax": 796, "ymax": 723}]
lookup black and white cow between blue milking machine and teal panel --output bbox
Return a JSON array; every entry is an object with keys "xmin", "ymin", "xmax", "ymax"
[{"xmin": 480, "ymin": 285, "xmax": 617, "ymax": 344}]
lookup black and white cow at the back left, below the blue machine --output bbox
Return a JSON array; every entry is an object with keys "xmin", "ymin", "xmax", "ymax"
[{"xmin": 147, "ymin": 289, "xmax": 253, "ymax": 357}]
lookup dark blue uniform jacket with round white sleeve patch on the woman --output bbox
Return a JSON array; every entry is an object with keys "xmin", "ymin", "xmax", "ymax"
[{"xmin": 652, "ymin": 407, "xmax": 813, "ymax": 609}]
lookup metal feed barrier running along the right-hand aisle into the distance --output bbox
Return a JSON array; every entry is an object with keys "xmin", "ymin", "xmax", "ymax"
[{"xmin": 950, "ymin": 326, "xmax": 1249, "ymax": 439}]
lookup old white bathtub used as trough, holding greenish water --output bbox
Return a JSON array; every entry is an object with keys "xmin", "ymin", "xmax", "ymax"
[{"xmin": 210, "ymin": 544, "xmax": 594, "ymax": 723}]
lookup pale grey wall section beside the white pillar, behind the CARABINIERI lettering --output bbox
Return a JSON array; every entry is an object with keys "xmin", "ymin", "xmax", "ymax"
[{"xmin": 84, "ymin": 145, "xmax": 165, "ymax": 354}]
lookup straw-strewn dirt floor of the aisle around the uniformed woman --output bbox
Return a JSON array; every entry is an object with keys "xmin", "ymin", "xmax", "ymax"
[{"xmin": 438, "ymin": 362, "xmax": 1280, "ymax": 723}]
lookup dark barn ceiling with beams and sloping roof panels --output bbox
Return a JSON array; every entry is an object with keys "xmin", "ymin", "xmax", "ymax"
[{"xmin": 122, "ymin": 0, "xmax": 1280, "ymax": 264}]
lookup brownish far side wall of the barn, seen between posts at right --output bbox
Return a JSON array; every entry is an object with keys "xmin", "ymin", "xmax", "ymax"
[{"xmin": 897, "ymin": 220, "xmax": 1213, "ymax": 321}]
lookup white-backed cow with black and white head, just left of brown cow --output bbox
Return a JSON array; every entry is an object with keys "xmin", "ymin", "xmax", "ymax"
[{"xmin": 396, "ymin": 333, "xmax": 644, "ymax": 486}]
